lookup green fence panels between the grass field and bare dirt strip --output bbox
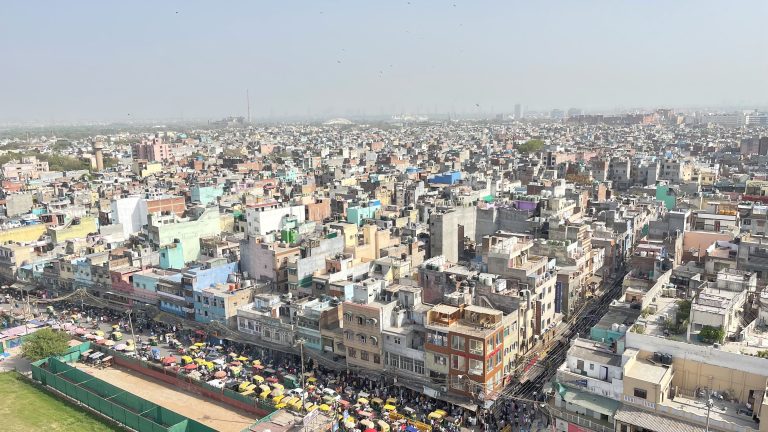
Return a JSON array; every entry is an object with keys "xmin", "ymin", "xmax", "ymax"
[{"xmin": 32, "ymin": 356, "xmax": 215, "ymax": 432}]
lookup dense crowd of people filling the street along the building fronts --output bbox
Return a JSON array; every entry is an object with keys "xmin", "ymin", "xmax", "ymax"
[{"xmin": 18, "ymin": 302, "xmax": 549, "ymax": 432}]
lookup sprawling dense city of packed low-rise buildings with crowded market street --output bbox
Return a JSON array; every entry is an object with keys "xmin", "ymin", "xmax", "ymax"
[{"xmin": 0, "ymin": 108, "xmax": 768, "ymax": 432}]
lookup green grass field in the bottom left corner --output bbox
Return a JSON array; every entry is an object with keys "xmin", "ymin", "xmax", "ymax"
[{"xmin": 0, "ymin": 372, "xmax": 120, "ymax": 432}]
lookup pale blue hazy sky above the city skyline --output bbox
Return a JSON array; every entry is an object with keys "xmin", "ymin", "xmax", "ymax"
[{"xmin": 0, "ymin": 0, "xmax": 768, "ymax": 122}]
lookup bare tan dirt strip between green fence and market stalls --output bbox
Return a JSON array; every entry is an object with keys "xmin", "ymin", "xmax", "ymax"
[{"xmin": 77, "ymin": 363, "xmax": 258, "ymax": 432}]
